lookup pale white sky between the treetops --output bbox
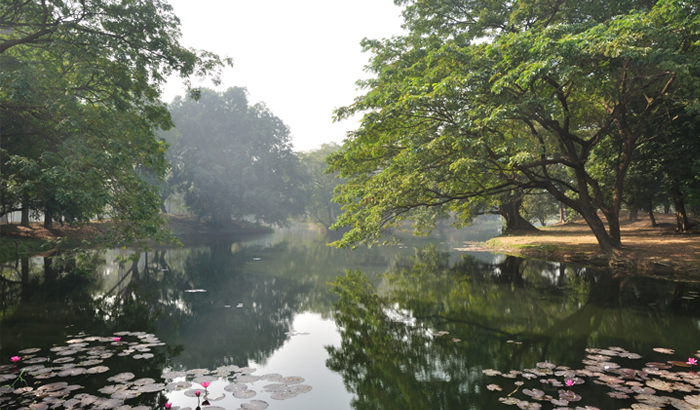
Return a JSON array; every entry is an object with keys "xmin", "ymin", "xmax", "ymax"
[{"xmin": 164, "ymin": 0, "xmax": 402, "ymax": 151}]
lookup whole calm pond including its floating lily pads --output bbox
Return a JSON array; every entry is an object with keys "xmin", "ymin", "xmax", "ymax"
[{"xmin": 0, "ymin": 225, "xmax": 700, "ymax": 410}]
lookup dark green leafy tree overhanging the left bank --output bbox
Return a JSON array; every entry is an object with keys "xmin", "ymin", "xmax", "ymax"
[{"xmin": 0, "ymin": 0, "xmax": 230, "ymax": 242}]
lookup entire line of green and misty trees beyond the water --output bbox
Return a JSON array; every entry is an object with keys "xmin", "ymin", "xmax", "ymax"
[{"xmin": 0, "ymin": 0, "xmax": 700, "ymax": 253}]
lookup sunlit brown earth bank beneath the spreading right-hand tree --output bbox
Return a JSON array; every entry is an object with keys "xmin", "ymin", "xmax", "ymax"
[{"xmin": 485, "ymin": 213, "xmax": 700, "ymax": 279}]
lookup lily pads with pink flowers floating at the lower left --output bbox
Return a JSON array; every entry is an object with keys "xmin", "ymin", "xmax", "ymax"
[{"xmin": 0, "ymin": 332, "xmax": 312, "ymax": 410}]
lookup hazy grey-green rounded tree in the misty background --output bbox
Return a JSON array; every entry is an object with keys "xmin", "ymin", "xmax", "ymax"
[{"xmin": 164, "ymin": 87, "xmax": 304, "ymax": 224}]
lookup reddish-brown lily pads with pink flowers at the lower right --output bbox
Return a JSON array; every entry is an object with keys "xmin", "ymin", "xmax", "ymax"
[{"xmin": 483, "ymin": 347, "xmax": 700, "ymax": 410}]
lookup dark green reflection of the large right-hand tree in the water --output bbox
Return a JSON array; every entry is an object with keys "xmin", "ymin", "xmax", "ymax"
[{"xmin": 327, "ymin": 247, "xmax": 700, "ymax": 409}]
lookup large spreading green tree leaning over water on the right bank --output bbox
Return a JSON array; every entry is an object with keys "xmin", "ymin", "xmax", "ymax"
[{"xmin": 330, "ymin": 0, "xmax": 700, "ymax": 253}]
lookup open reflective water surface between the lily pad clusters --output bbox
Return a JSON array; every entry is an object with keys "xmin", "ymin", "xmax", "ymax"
[{"xmin": 0, "ymin": 227, "xmax": 700, "ymax": 409}]
